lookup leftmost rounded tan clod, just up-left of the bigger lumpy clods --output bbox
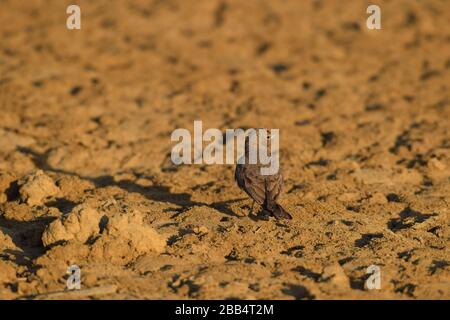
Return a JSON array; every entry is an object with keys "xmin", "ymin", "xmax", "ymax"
[{"xmin": 18, "ymin": 170, "xmax": 59, "ymax": 206}]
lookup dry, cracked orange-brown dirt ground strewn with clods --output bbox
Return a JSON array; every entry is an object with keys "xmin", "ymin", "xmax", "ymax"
[{"xmin": 0, "ymin": 0, "xmax": 450, "ymax": 299}]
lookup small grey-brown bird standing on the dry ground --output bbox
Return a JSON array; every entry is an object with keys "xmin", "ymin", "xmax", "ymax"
[{"xmin": 234, "ymin": 129, "xmax": 292, "ymax": 219}]
